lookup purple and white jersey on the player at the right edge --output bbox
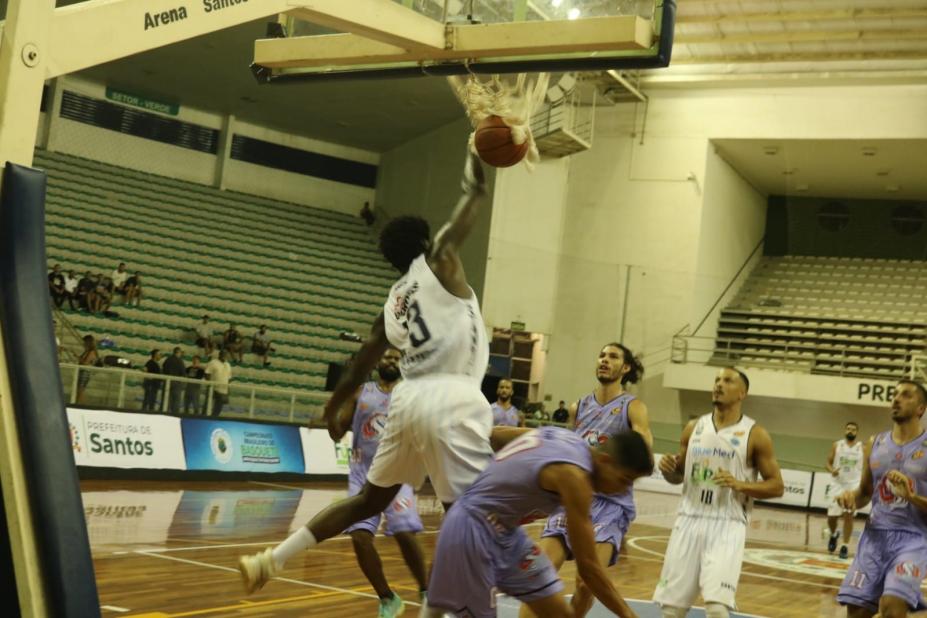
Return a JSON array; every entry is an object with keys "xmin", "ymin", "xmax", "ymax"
[{"xmin": 868, "ymin": 431, "xmax": 927, "ymax": 537}]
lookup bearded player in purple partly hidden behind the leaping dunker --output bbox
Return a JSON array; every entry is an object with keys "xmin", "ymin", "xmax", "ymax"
[{"xmin": 335, "ymin": 347, "xmax": 427, "ymax": 618}]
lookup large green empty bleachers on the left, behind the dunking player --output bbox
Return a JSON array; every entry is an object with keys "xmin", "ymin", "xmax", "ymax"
[{"xmin": 35, "ymin": 151, "xmax": 393, "ymax": 418}]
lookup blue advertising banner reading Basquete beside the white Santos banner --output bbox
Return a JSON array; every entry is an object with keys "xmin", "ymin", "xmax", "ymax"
[{"xmin": 181, "ymin": 418, "xmax": 304, "ymax": 474}]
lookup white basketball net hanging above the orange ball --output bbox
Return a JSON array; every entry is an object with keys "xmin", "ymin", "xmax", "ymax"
[{"xmin": 448, "ymin": 73, "xmax": 549, "ymax": 169}]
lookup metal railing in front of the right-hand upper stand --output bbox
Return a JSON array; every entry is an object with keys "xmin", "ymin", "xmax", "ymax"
[{"xmin": 672, "ymin": 335, "xmax": 927, "ymax": 379}]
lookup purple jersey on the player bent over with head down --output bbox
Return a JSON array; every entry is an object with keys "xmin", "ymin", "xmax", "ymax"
[{"xmin": 454, "ymin": 427, "xmax": 592, "ymax": 533}]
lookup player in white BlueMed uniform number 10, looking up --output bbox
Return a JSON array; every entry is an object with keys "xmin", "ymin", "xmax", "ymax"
[{"xmin": 653, "ymin": 367, "xmax": 784, "ymax": 618}]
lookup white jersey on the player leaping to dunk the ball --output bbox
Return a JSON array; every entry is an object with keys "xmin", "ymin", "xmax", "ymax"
[{"xmin": 383, "ymin": 254, "xmax": 489, "ymax": 383}]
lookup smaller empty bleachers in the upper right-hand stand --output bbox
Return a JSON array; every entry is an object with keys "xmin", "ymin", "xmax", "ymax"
[{"xmin": 711, "ymin": 256, "xmax": 927, "ymax": 379}]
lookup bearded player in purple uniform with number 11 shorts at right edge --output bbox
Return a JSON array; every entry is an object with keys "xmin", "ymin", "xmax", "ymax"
[{"xmin": 837, "ymin": 380, "xmax": 927, "ymax": 618}]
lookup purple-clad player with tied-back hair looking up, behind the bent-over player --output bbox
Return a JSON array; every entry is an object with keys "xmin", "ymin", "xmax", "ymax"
[{"xmin": 521, "ymin": 343, "xmax": 653, "ymax": 617}]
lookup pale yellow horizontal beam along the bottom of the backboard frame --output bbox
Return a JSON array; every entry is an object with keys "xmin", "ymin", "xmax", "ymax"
[{"xmin": 254, "ymin": 15, "xmax": 653, "ymax": 68}]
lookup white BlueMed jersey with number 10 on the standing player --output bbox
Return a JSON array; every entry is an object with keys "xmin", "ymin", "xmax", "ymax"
[{"xmin": 679, "ymin": 414, "xmax": 757, "ymax": 523}]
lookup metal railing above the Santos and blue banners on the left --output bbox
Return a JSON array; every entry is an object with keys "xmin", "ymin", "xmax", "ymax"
[{"xmin": 59, "ymin": 363, "xmax": 326, "ymax": 424}]
